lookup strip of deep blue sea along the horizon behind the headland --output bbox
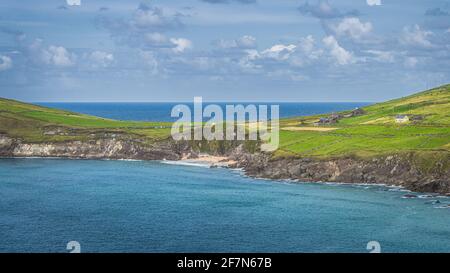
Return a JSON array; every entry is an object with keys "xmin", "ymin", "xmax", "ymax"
[{"xmin": 36, "ymin": 102, "xmax": 368, "ymax": 121}]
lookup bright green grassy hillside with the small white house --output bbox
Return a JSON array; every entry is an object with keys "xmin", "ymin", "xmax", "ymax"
[{"xmin": 276, "ymin": 85, "xmax": 450, "ymax": 157}]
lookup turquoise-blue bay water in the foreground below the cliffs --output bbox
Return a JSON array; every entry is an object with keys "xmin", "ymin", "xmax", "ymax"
[{"xmin": 0, "ymin": 159, "xmax": 450, "ymax": 252}]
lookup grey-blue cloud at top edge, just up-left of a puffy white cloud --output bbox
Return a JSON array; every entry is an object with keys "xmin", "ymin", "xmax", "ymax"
[{"xmin": 298, "ymin": 0, "xmax": 359, "ymax": 19}]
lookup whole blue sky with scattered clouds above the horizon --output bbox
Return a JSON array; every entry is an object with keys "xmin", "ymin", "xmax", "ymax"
[{"xmin": 0, "ymin": 0, "xmax": 450, "ymax": 102}]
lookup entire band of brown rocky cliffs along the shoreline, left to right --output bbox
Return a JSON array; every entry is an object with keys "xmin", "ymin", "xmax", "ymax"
[{"xmin": 0, "ymin": 135, "xmax": 450, "ymax": 194}]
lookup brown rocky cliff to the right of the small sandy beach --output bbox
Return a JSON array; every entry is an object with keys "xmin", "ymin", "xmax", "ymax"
[{"xmin": 231, "ymin": 151, "xmax": 450, "ymax": 194}]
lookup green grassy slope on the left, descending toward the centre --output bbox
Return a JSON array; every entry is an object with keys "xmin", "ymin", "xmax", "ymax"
[{"xmin": 0, "ymin": 98, "xmax": 171, "ymax": 142}]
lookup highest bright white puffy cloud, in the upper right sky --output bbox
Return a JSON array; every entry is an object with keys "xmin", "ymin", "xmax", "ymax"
[{"xmin": 330, "ymin": 17, "xmax": 372, "ymax": 41}]
